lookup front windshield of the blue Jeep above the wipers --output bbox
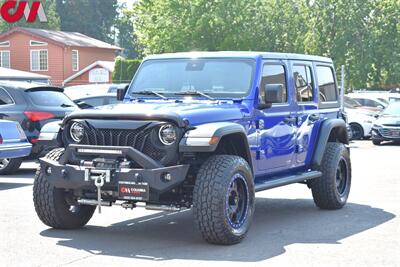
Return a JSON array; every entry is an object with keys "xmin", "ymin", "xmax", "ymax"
[{"xmin": 129, "ymin": 59, "xmax": 254, "ymax": 98}]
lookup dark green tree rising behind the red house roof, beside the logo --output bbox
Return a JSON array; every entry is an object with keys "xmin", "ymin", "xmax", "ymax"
[{"xmin": 56, "ymin": 0, "xmax": 118, "ymax": 43}]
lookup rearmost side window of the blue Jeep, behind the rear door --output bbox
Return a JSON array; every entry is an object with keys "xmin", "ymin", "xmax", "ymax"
[{"xmin": 317, "ymin": 66, "xmax": 338, "ymax": 102}]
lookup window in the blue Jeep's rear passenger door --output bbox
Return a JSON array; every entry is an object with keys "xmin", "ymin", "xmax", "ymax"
[{"xmin": 293, "ymin": 65, "xmax": 314, "ymax": 102}]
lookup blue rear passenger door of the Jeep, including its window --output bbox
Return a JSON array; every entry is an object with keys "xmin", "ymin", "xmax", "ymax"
[{"xmin": 292, "ymin": 61, "xmax": 321, "ymax": 166}]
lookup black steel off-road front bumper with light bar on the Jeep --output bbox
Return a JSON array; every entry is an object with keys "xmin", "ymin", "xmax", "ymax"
[{"xmin": 40, "ymin": 145, "xmax": 189, "ymax": 194}]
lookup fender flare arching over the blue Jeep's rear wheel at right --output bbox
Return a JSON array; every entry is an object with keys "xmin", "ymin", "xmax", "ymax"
[{"xmin": 312, "ymin": 119, "xmax": 349, "ymax": 166}]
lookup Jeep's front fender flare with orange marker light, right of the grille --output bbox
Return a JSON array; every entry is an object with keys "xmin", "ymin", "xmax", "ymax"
[{"xmin": 179, "ymin": 122, "xmax": 252, "ymax": 166}]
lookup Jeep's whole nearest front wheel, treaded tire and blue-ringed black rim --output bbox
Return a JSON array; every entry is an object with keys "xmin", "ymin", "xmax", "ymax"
[{"xmin": 193, "ymin": 155, "xmax": 255, "ymax": 245}]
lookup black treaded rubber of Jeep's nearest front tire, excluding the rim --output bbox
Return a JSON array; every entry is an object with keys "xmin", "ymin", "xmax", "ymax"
[{"xmin": 193, "ymin": 155, "xmax": 254, "ymax": 245}]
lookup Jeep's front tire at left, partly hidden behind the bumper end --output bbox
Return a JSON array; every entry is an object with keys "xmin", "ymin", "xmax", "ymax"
[{"xmin": 33, "ymin": 148, "xmax": 96, "ymax": 229}]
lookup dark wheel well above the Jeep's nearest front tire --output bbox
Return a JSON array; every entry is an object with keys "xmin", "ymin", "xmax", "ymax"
[{"xmin": 215, "ymin": 133, "xmax": 252, "ymax": 167}]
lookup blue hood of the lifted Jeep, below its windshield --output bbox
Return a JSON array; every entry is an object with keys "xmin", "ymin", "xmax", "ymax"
[{"xmin": 66, "ymin": 100, "xmax": 249, "ymax": 127}]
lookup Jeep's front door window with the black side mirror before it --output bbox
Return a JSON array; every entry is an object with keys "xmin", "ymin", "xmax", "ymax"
[{"xmin": 260, "ymin": 64, "xmax": 287, "ymax": 103}]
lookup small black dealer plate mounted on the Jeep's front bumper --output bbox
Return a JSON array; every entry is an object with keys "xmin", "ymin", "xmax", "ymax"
[{"xmin": 118, "ymin": 181, "xmax": 150, "ymax": 201}]
